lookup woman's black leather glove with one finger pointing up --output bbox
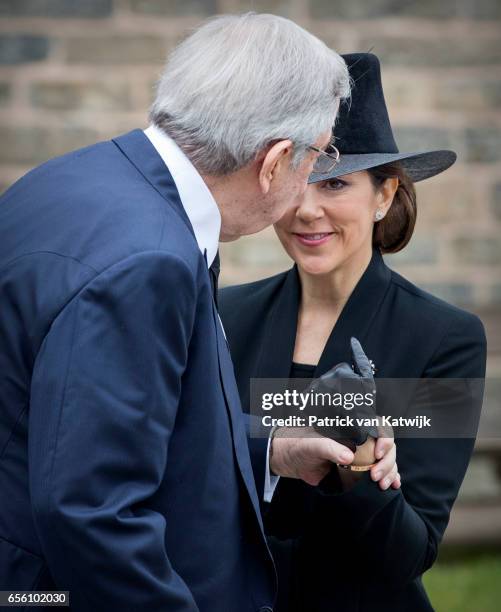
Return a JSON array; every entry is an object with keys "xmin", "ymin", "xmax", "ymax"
[{"xmin": 307, "ymin": 338, "xmax": 379, "ymax": 452}]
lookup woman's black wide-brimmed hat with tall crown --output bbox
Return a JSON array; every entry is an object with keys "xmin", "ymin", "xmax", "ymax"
[{"xmin": 308, "ymin": 53, "xmax": 457, "ymax": 183}]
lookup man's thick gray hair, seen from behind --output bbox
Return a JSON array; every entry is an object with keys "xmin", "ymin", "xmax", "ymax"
[{"xmin": 150, "ymin": 13, "xmax": 350, "ymax": 175}]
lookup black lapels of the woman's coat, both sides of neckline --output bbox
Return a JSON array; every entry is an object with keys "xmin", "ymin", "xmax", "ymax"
[{"xmin": 256, "ymin": 250, "xmax": 391, "ymax": 378}]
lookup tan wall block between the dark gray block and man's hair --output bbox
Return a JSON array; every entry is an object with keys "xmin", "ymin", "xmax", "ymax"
[{"xmin": 66, "ymin": 35, "xmax": 167, "ymax": 65}]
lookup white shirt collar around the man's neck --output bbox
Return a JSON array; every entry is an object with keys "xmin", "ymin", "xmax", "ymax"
[{"xmin": 144, "ymin": 125, "xmax": 221, "ymax": 267}]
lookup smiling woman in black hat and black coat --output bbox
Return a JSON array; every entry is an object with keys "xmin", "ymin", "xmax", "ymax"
[{"xmin": 219, "ymin": 54, "xmax": 486, "ymax": 612}]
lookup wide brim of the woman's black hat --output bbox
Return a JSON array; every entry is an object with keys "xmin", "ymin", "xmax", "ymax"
[{"xmin": 308, "ymin": 150, "xmax": 457, "ymax": 183}]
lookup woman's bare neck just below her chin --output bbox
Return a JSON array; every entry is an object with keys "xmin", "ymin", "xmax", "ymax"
[{"xmin": 298, "ymin": 244, "xmax": 372, "ymax": 315}]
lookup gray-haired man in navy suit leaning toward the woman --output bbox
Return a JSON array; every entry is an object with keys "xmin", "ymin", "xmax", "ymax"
[{"xmin": 0, "ymin": 14, "xmax": 390, "ymax": 612}]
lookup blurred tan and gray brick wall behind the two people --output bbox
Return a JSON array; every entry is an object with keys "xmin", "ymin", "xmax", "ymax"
[{"xmin": 0, "ymin": 0, "xmax": 501, "ymax": 320}]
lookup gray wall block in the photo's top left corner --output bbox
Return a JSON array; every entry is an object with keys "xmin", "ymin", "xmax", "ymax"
[{"xmin": 0, "ymin": 0, "xmax": 113, "ymax": 17}]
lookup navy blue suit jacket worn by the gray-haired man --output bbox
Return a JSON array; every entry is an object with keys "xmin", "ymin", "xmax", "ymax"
[{"xmin": 0, "ymin": 130, "xmax": 275, "ymax": 612}]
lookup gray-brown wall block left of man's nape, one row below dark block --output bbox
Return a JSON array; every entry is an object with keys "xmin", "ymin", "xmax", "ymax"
[{"xmin": 30, "ymin": 80, "xmax": 132, "ymax": 111}]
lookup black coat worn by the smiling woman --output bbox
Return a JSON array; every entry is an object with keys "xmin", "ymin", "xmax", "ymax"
[{"xmin": 219, "ymin": 252, "xmax": 486, "ymax": 612}]
